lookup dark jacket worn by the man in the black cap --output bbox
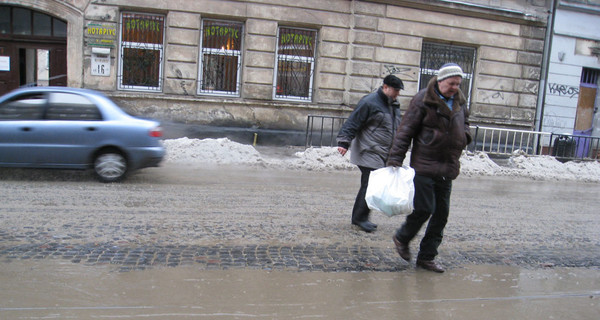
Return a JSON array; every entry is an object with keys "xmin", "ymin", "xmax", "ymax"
[{"xmin": 337, "ymin": 88, "xmax": 401, "ymax": 169}]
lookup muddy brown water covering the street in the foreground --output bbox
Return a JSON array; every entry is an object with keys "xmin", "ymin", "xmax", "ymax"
[{"xmin": 0, "ymin": 259, "xmax": 600, "ymax": 320}]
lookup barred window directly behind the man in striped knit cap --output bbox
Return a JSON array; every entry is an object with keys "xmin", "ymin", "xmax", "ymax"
[{"xmin": 419, "ymin": 41, "xmax": 477, "ymax": 106}]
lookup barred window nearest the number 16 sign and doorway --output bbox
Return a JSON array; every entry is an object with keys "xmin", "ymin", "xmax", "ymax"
[{"xmin": 117, "ymin": 13, "xmax": 165, "ymax": 91}]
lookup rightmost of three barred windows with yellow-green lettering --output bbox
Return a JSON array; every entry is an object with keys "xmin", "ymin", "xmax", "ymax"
[{"xmin": 273, "ymin": 27, "xmax": 317, "ymax": 101}]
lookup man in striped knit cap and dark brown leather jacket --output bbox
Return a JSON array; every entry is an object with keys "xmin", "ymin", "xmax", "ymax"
[{"xmin": 387, "ymin": 63, "xmax": 471, "ymax": 273}]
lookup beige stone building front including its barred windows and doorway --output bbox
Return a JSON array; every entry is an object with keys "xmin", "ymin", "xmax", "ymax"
[{"xmin": 0, "ymin": 0, "xmax": 552, "ymax": 142}]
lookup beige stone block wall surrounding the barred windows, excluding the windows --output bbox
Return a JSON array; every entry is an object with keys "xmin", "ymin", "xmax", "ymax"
[{"xmin": 0, "ymin": 0, "xmax": 547, "ymax": 134}]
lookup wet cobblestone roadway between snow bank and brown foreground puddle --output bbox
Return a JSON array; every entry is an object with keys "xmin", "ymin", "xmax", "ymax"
[{"xmin": 0, "ymin": 167, "xmax": 600, "ymax": 272}]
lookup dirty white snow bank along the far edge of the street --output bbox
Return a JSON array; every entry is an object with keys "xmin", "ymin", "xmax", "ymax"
[{"xmin": 164, "ymin": 138, "xmax": 600, "ymax": 182}]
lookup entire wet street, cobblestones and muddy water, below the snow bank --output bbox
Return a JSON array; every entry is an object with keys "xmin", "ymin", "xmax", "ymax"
[{"xmin": 0, "ymin": 166, "xmax": 600, "ymax": 320}]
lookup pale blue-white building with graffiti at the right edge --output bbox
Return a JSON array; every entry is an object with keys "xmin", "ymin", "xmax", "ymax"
[{"xmin": 538, "ymin": 0, "xmax": 600, "ymax": 145}]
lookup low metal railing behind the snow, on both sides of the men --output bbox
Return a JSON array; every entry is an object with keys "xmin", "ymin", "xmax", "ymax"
[{"xmin": 305, "ymin": 115, "xmax": 600, "ymax": 161}]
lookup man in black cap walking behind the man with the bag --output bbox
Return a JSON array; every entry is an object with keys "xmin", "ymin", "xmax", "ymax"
[{"xmin": 337, "ymin": 75, "xmax": 404, "ymax": 232}]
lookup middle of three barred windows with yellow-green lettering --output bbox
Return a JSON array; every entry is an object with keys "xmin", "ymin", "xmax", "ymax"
[{"xmin": 198, "ymin": 19, "xmax": 243, "ymax": 96}]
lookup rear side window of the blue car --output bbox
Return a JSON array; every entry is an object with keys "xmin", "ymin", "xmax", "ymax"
[{"xmin": 46, "ymin": 92, "xmax": 102, "ymax": 121}]
